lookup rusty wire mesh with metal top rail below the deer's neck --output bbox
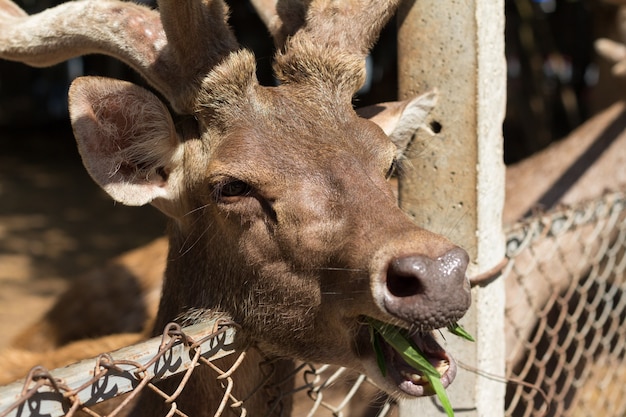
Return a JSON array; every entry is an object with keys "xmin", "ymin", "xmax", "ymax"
[{"xmin": 0, "ymin": 320, "xmax": 395, "ymax": 417}]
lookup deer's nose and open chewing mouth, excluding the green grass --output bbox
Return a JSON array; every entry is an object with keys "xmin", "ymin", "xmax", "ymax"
[{"xmin": 360, "ymin": 243, "xmax": 471, "ymax": 397}]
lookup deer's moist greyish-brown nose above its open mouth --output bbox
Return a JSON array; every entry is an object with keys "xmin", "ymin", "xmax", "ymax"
[{"xmin": 383, "ymin": 248, "xmax": 471, "ymax": 330}]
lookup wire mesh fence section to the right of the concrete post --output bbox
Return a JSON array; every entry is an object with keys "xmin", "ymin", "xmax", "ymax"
[{"xmin": 506, "ymin": 194, "xmax": 626, "ymax": 416}]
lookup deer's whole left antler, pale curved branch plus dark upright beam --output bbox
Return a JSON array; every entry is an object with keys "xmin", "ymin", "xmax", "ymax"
[{"xmin": 0, "ymin": 0, "xmax": 238, "ymax": 113}]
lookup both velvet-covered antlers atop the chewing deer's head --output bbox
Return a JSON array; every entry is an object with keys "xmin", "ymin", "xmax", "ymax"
[{"xmin": 0, "ymin": 0, "xmax": 399, "ymax": 113}]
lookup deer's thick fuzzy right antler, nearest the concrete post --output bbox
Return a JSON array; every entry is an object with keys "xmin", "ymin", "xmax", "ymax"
[{"xmin": 252, "ymin": 0, "xmax": 399, "ymax": 94}]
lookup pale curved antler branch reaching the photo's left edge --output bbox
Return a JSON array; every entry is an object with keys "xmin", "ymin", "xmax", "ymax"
[{"xmin": 0, "ymin": 0, "xmax": 173, "ymax": 107}]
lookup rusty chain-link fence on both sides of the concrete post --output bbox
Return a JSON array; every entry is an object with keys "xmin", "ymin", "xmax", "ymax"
[{"xmin": 0, "ymin": 193, "xmax": 626, "ymax": 417}]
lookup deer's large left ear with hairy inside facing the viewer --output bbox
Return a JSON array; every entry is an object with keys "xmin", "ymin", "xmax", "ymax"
[{"xmin": 69, "ymin": 77, "xmax": 181, "ymax": 206}]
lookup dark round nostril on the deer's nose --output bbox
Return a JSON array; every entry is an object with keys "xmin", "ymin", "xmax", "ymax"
[{"xmin": 387, "ymin": 257, "xmax": 426, "ymax": 298}]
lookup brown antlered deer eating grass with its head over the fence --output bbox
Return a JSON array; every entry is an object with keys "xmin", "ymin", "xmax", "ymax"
[{"xmin": 0, "ymin": 0, "xmax": 471, "ymax": 416}]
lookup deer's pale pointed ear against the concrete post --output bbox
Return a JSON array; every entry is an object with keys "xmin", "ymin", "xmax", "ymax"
[{"xmin": 357, "ymin": 90, "xmax": 438, "ymax": 153}]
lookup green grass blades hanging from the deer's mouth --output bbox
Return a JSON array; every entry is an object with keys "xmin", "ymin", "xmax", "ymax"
[{"xmin": 367, "ymin": 317, "xmax": 474, "ymax": 417}]
